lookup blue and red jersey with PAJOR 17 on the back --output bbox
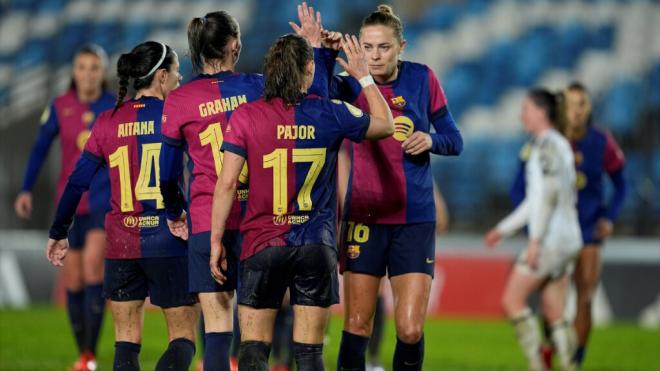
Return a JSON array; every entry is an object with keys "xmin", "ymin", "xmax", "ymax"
[{"xmin": 222, "ymin": 96, "xmax": 369, "ymax": 260}]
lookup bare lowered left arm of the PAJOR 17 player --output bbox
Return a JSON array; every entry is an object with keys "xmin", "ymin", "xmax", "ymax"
[{"xmin": 209, "ymin": 151, "xmax": 245, "ymax": 284}]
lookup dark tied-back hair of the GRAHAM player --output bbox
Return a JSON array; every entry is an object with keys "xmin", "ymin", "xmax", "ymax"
[{"xmin": 188, "ymin": 10, "xmax": 240, "ymax": 72}]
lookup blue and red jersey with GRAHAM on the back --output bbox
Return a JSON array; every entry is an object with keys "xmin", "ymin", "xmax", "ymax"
[{"xmin": 161, "ymin": 72, "xmax": 263, "ymax": 233}]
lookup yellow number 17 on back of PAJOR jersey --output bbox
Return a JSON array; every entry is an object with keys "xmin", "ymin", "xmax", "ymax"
[{"xmin": 263, "ymin": 148, "xmax": 326, "ymax": 215}]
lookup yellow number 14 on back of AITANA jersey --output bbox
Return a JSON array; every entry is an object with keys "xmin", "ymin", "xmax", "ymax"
[{"xmin": 108, "ymin": 143, "xmax": 164, "ymax": 212}]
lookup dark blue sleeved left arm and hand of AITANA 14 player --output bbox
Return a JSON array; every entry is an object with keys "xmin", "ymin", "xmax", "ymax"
[{"xmin": 46, "ymin": 151, "xmax": 103, "ymax": 266}]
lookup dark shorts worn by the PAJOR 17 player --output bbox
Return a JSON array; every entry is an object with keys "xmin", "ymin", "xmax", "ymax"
[{"xmin": 238, "ymin": 245, "xmax": 339, "ymax": 309}]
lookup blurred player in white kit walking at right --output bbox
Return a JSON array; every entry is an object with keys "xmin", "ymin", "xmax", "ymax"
[{"xmin": 484, "ymin": 89, "xmax": 581, "ymax": 370}]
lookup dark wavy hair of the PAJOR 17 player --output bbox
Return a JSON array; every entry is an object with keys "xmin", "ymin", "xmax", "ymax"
[{"xmin": 264, "ymin": 34, "xmax": 314, "ymax": 104}]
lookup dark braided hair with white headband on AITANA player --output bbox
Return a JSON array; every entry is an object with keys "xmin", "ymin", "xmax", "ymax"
[{"xmin": 112, "ymin": 41, "xmax": 174, "ymax": 114}]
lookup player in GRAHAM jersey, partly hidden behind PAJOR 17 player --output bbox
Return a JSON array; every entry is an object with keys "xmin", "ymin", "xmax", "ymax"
[{"xmin": 160, "ymin": 8, "xmax": 332, "ymax": 370}]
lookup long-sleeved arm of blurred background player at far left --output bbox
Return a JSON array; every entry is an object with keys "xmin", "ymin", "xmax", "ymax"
[{"xmin": 14, "ymin": 105, "xmax": 59, "ymax": 219}]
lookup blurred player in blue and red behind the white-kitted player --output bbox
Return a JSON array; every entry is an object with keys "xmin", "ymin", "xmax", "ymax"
[{"xmin": 511, "ymin": 82, "xmax": 627, "ymax": 366}]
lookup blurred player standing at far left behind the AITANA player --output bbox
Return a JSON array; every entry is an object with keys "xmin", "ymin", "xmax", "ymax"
[{"xmin": 15, "ymin": 45, "xmax": 115, "ymax": 371}]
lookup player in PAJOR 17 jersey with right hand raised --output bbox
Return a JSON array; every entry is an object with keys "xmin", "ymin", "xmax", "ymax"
[{"xmin": 210, "ymin": 35, "xmax": 394, "ymax": 370}]
